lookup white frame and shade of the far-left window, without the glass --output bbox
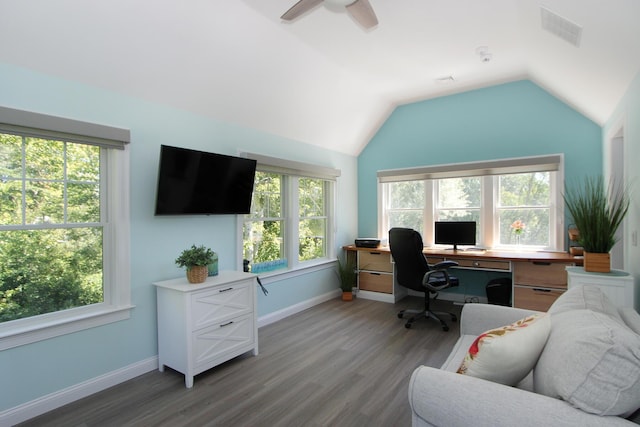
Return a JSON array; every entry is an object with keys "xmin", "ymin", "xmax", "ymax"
[{"xmin": 0, "ymin": 107, "xmax": 134, "ymax": 351}]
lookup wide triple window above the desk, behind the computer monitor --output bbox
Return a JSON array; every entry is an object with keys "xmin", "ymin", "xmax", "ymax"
[{"xmin": 378, "ymin": 155, "xmax": 564, "ymax": 250}]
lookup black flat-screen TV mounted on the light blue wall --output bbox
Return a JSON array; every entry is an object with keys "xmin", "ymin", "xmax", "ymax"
[{"xmin": 155, "ymin": 145, "xmax": 256, "ymax": 215}]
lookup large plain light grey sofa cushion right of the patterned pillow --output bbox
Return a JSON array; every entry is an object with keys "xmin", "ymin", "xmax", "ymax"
[{"xmin": 533, "ymin": 309, "xmax": 640, "ymax": 415}]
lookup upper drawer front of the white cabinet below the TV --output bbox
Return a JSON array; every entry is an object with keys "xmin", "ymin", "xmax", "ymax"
[{"xmin": 191, "ymin": 281, "xmax": 255, "ymax": 331}]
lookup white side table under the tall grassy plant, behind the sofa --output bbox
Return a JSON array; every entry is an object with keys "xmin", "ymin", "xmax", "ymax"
[{"xmin": 567, "ymin": 267, "xmax": 638, "ymax": 310}]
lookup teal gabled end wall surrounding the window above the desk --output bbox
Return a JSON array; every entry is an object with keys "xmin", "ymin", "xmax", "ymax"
[{"xmin": 358, "ymin": 80, "xmax": 602, "ymax": 238}]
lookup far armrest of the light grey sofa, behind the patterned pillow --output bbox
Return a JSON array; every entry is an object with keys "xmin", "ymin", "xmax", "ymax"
[{"xmin": 460, "ymin": 304, "xmax": 539, "ymax": 336}]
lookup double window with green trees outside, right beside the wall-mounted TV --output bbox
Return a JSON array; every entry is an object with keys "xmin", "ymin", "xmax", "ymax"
[{"xmin": 242, "ymin": 154, "xmax": 339, "ymax": 273}]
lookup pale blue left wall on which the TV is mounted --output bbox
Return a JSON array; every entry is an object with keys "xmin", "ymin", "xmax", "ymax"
[{"xmin": 0, "ymin": 63, "xmax": 357, "ymax": 413}]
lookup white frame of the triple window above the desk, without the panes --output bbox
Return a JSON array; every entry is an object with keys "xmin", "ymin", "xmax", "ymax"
[{"xmin": 377, "ymin": 153, "xmax": 566, "ymax": 251}]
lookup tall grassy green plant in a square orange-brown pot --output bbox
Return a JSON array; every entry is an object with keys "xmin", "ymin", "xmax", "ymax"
[{"xmin": 563, "ymin": 177, "xmax": 629, "ymax": 273}]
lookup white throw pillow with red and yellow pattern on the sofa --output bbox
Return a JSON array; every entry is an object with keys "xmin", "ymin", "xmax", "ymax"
[{"xmin": 458, "ymin": 313, "xmax": 551, "ymax": 386}]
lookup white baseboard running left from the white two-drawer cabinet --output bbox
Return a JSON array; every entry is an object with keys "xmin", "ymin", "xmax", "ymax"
[{"xmin": 0, "ymin": 356, "xmax": 158, "ymax": 426}]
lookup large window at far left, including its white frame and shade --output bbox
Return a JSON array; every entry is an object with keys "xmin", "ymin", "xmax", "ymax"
[{"xmin": 0, "ymin": 108, "xmax": 131, "ymax": 349}]
